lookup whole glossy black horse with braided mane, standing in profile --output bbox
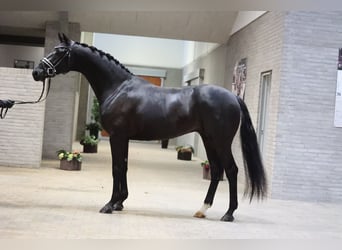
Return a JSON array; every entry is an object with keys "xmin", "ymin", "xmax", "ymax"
[{"xmin": 32, "ymin": 34, "xmax": 266, "ymax": 221}]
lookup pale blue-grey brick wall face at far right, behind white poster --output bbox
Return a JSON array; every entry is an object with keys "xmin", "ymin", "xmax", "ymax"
[{"xmin": 272, "ymin": 12, "xmax": 342, "ymax": 201}]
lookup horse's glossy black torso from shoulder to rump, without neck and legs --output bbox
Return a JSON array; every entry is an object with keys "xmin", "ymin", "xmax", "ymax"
[{"xmin": 103, "ymin": 77, "xmax": 240, "ymax": 143}]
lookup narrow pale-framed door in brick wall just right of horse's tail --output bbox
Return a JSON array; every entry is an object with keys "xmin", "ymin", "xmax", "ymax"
[{"xmin": 257, "ymin": 71, "xmax": 272, "ymax": 155}]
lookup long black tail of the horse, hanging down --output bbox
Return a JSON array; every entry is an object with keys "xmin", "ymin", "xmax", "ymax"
[{"xmin": 237, "ymin": 97, "xmax": 267, "ymax": 201}]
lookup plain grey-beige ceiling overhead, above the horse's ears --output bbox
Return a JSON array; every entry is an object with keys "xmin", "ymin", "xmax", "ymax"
[{"xmin": 0, "ymin": 10, "xmax": 239, "ymax": 44}]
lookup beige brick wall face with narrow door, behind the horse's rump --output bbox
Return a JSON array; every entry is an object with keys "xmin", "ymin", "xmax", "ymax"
[{"xmin": 225, "ymin": 12, "xmax": 284, "ymax": 193}]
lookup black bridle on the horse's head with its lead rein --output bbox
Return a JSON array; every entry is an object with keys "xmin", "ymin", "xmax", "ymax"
[{"xmin": 0, "ymin": 46, "xmax": 71, "ymax": 119}]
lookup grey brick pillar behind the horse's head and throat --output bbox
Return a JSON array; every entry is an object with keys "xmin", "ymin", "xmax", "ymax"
[{"xmin": 43, "ymin": 21, "xmax": 81, "ymax": 158}]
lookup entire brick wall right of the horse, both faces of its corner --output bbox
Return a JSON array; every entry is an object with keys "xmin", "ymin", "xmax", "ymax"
[{"xmin": 226, "ymin": 12, "xmax": 342, "ymax": 201}]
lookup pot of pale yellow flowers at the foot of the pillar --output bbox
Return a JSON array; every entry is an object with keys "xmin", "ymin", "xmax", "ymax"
[{"xmin": 57, "ymin": 149, "xmax": 82, "ymax": 170}]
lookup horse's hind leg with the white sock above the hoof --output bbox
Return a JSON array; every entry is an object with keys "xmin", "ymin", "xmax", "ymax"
[{"xmin": 194, "ymin": 143, "xmax": 223, "ymax": 218}]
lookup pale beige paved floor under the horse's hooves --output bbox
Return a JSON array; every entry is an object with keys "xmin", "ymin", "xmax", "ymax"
[{"xmin": 0, "ymin": 141, "xmax": 342, "ymax": 239}]
